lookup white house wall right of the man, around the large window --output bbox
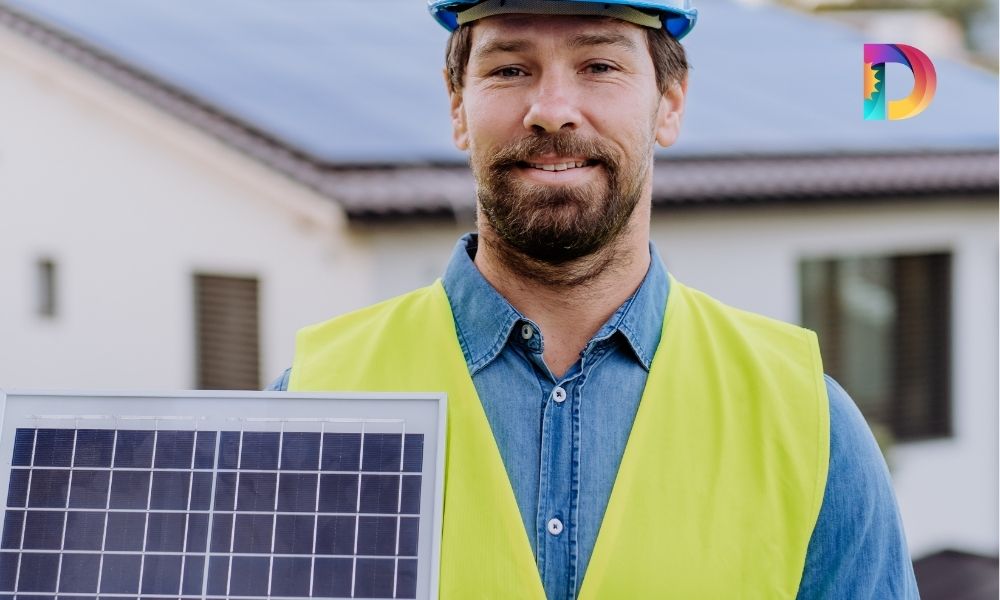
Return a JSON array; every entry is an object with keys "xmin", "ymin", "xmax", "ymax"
[{"xmin": 652, "ymin": 198, "xmax": 1000, "ymax": 557}]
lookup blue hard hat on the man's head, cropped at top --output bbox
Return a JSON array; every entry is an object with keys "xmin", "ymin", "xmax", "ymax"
[{"xmin": 427, "ymin": 0, "xmax": 698, "ymax": 40}]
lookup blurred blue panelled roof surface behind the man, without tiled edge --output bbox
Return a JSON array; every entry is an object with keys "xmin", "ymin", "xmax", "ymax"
[{"xmin": 0, "ymin": 0, "xmax": 997, "ymax": 165}]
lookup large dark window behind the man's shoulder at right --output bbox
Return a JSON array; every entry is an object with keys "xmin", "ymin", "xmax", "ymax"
[{"xmin": 800, "ymin": 253, "xmax": 951, "ymax": 440}]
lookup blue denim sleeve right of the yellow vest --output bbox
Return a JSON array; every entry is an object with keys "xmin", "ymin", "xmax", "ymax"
[{"xmin": 798, "ymin": 377, "xmax": 920, "ymax": 600}]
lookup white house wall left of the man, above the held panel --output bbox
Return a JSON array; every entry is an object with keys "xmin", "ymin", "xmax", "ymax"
[{"xmin": 0, "ymin": 31, "xmax": 373, "ymax": 389}]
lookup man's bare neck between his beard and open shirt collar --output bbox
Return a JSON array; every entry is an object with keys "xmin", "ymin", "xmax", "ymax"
[{"xmin": 475, "ymin": 215, "xmax": 650, "ymax": 378}]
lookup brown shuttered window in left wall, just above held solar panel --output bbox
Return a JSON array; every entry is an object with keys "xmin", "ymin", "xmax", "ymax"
[{"xmin": 194, "ymin": 275, "xmax": 260, "ymax": 390}]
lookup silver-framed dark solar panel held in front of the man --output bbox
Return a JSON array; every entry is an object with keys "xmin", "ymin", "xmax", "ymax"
[{"xmin": 0, "ymin": 392, "xmax": 445, "ymax": 600}]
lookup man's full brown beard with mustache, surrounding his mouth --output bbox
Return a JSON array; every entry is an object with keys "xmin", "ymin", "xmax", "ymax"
[{"xmin": 471, "ymin": 131, "xmax": 650, "ymax": 266}]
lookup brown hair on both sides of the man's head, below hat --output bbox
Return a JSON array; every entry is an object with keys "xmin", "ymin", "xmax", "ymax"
[{"xmin": 445, "ymin": 17, "xmax": 689, "ymax": 94}]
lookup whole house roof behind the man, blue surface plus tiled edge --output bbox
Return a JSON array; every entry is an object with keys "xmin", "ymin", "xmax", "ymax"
[{"xmin": 0, "ymin": 0, "xmax": 998, "ymax": 217}]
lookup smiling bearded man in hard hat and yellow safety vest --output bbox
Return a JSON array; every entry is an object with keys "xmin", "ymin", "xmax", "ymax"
[{"xmin": 274, "ymin": 0, "xmax": 917, "ymax": 598}]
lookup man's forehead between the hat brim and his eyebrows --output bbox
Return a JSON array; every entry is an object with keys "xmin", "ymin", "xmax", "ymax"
[{"xmin": 472, "ymin": 14, "xmax": 646, "ymax": 59}]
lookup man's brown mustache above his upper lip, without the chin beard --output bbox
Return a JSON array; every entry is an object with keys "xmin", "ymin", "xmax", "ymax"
[{"xmin": 486, "ymin": 131, "xmax": 619, "ymax": 171}]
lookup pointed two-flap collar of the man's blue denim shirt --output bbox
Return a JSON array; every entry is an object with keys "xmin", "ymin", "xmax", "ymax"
[{"xmin": 442, "ymin": 233, "xmax": 670, "ymax": 375}]
